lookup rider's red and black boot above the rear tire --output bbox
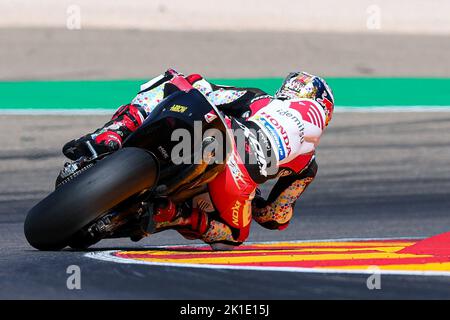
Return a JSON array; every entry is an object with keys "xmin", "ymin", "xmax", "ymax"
[{"xmin": 62, "ymin": 104, "xmax": 146, "ymax": 160}]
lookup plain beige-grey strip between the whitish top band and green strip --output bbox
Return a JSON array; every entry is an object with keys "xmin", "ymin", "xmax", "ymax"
[{"xmin": 0, "ymin": 29, "xmax": 450, "ymax": 79}]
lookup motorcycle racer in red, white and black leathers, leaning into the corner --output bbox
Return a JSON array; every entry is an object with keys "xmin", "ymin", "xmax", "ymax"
[{"xmin": 63, "ymin": 69, "xmax": 334, "ymax": 249}]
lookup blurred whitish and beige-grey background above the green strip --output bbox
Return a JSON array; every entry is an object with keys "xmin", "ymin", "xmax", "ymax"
[{"xmin": 0, "ymin": 0, "xmax": 450, "ymax": 80}]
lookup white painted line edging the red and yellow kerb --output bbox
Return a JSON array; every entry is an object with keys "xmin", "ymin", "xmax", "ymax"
[{"xmin": 85, "ymin": 237, "xmax": 450, "ymax": 277}]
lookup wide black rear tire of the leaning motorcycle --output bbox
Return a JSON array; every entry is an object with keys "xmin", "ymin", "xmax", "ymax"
[{"xmin": 24, "ymin": 148, "xmax": 158, "ymax": 250}]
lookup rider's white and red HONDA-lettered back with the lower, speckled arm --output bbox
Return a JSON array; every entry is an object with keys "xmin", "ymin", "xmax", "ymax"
[{"xmin": 243, "ymin": 97, "xmax": 325, "ymax": 229}]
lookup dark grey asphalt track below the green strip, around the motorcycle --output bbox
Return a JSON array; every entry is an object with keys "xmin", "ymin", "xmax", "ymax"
[{"xmin": 0, "ymin": 112, "xmax": 450, "ymax": 299}]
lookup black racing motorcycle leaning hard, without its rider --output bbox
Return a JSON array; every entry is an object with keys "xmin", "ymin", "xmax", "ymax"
[{"xmin": 24, "ymin": 77, "xmax": 232, "ymax": 250}]
